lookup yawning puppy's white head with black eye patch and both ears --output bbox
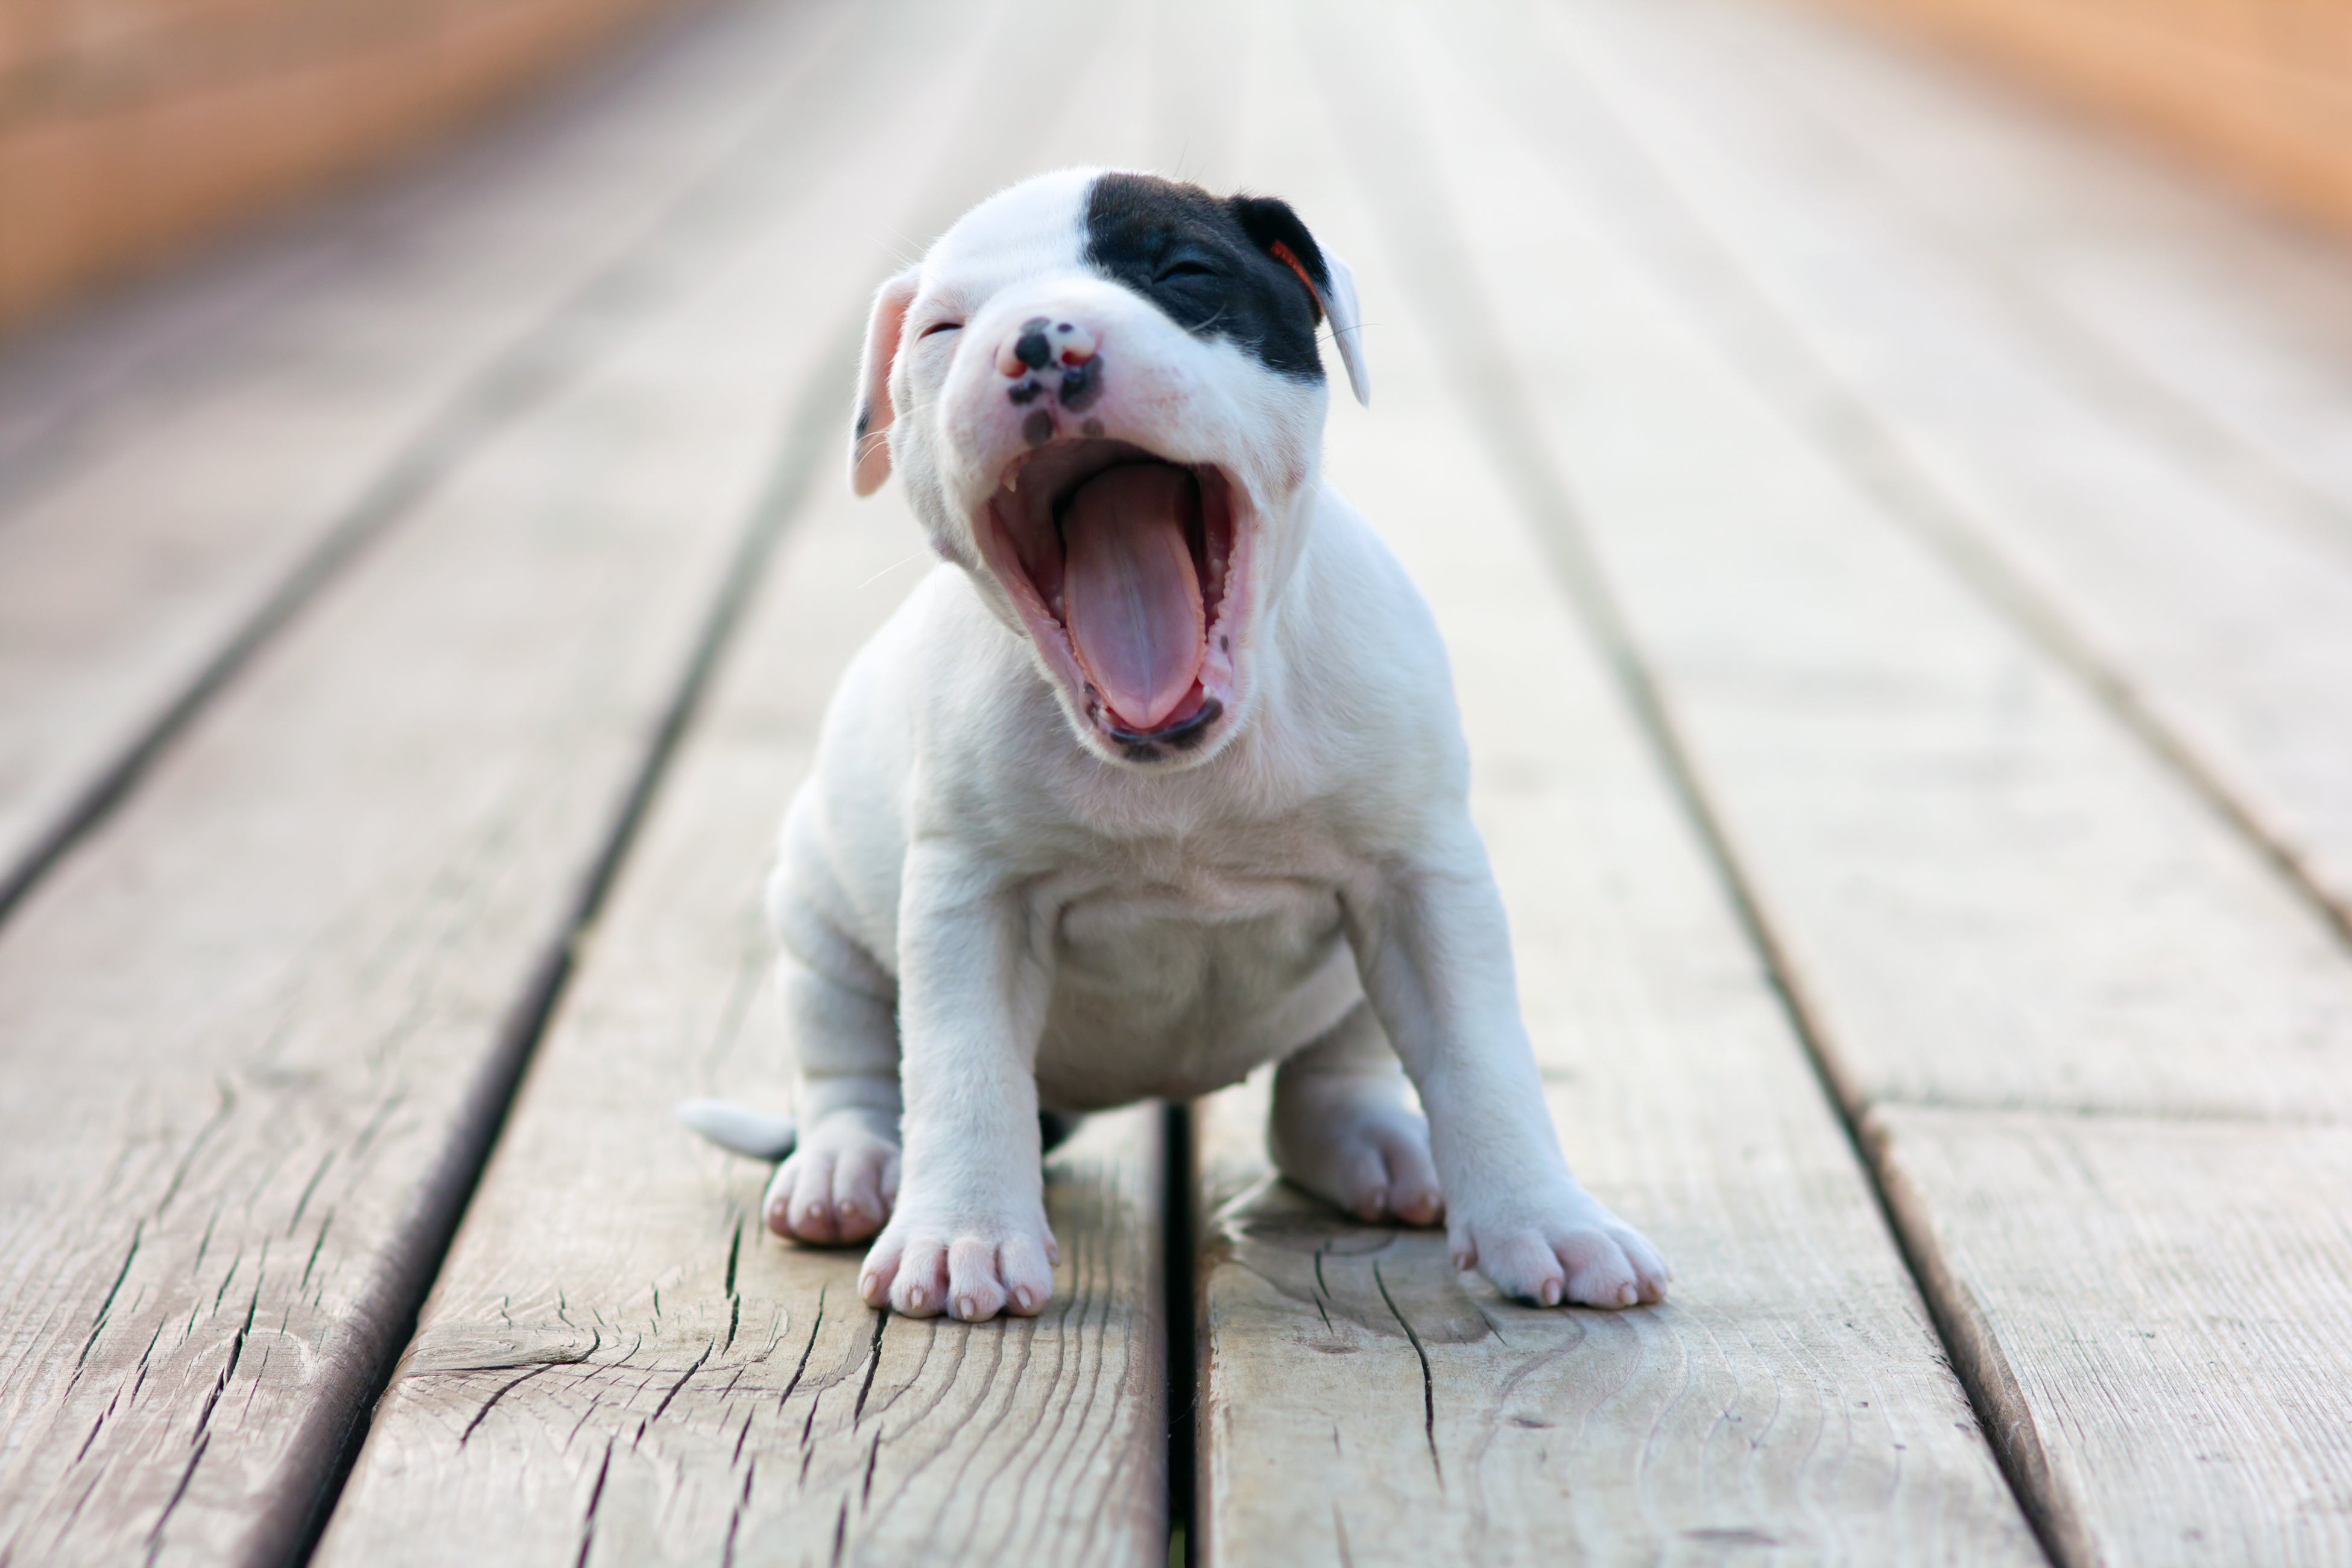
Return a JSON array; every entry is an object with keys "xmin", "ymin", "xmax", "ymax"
[{"xmin": 849, "ymin": 169, "xmax": 1369, "ymax": 767}]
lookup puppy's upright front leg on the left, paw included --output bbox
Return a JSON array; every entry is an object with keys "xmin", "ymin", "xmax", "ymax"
[{"xmin": 859, "ymin": 839, "xmax": 1061, "ymax": 1321}]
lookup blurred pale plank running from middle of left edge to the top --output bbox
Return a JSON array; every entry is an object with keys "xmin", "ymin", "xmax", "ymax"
[{"xmin": 0, "ymin": 10, "xmax": 865, "ymax": 908}]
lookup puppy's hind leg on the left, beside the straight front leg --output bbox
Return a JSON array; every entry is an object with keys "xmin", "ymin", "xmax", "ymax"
[{"xmin": 765, "ymin": 910, "xmax": 901, "ymax": 1244}]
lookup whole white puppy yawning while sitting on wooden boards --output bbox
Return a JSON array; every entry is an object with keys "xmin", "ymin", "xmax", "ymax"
[{"xmin": 689, "ymin": 169, "xmax": 1668, "ymax": 1319}]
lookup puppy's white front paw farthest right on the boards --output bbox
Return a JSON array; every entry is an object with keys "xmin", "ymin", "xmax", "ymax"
[{"xmin": 1447, "ymin": 1187, "xmax": 1675, "ymax": 1307}]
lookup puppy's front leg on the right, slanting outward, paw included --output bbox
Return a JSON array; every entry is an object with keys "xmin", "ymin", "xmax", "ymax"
[{"xmin": 1348, "ymin": 818, "xmax": 1670, "ymax": 1307}]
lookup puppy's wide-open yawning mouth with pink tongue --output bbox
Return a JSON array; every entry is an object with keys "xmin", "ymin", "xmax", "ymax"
[{"xmin": 983, "ymin": 437, "xmax": 1249, "ymax": 757}]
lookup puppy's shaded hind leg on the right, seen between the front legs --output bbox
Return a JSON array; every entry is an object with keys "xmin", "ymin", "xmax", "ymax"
[{"xmin": 1265, "ymin": 1002, "xmax": 1444, "ymax": 1225}]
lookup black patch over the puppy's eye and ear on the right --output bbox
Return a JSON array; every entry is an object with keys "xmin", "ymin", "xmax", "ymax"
[{"xmin": 1087, "ymin": 174, "xmax": 1331, "ymax": 381}]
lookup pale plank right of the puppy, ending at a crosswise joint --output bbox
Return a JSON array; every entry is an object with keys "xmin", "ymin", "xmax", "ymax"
[{"xmin": 1392, "ymin": 10, "xmax": 2352, "ymax": 1117}]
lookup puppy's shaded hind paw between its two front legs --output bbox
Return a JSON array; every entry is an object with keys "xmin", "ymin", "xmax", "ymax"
[{"xmin": 1268, "ymin": 1072, "xmax": 1447, "ymax": 1225}]
